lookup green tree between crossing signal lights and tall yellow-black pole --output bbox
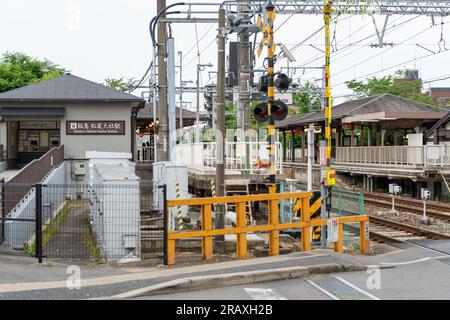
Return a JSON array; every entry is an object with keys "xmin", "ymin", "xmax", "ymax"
[{"xmin": 289, "ymin": 81, "xmax": 321, "ymax": 115}]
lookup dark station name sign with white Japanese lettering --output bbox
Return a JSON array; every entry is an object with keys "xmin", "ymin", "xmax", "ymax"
[{"xmin": 66, "ymin": 120, "xmax": 125, "ymax": 135}]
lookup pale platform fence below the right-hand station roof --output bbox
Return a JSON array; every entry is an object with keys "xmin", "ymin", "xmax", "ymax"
[{"xmin": 335, "ymin": 145, "xmax": 450, "ymax": 167}]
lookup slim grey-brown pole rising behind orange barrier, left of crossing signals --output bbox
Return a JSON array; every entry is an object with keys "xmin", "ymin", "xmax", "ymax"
[{"xmin": 215, "ymin": 9, "xmax": 226, "ymax": 241}]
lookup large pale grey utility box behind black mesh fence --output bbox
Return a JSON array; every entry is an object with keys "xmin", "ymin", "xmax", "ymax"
[{"xmin": 89, "ymin": 164, "xmax": 141, "ymax": 260}]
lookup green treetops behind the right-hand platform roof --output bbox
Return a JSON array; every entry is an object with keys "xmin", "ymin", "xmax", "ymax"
[{"xmin": 346, "ymin": 70, "xmax": 436, "ymax": 105}]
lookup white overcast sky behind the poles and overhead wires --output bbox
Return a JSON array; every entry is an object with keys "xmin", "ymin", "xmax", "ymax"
[{"xmin": 0, "ymin": 0, "xmax": 450, "ymax": 109}]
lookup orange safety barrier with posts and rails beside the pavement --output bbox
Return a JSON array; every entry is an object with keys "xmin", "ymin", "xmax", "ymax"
[{"xmin": 166, "ymin": 192, "xmax": 369, "ymax": 265}]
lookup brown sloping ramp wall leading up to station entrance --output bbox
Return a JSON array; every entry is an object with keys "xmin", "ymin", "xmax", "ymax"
[{"xmin": 3, "ymin": 145, "xmax": 64, "ymax": 214}]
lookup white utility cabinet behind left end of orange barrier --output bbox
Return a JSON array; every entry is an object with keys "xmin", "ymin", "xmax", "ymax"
[{"xmin": 153, "ymin": 161, "xmax": 191, "ymax": 216}]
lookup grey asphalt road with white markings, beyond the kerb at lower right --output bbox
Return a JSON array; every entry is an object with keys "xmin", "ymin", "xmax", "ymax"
[{"xmin": 138, "ymin": 257, "xmax": 450, "ymax": 300}]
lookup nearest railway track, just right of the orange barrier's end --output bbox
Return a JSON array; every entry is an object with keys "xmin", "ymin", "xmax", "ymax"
[{"xmin": 369, "ymin": 215, "xmax": 450, "ymax": 243}]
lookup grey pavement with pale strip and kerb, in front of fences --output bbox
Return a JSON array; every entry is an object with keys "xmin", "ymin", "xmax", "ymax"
[{"xmin": 0, "ymin": 250, "xmax": 366, "ymax": 299}]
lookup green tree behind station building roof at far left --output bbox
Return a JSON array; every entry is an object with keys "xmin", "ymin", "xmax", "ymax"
[{"xmin": 0, "ymin": 52, "xmax": 67, "ymax": 92}]
